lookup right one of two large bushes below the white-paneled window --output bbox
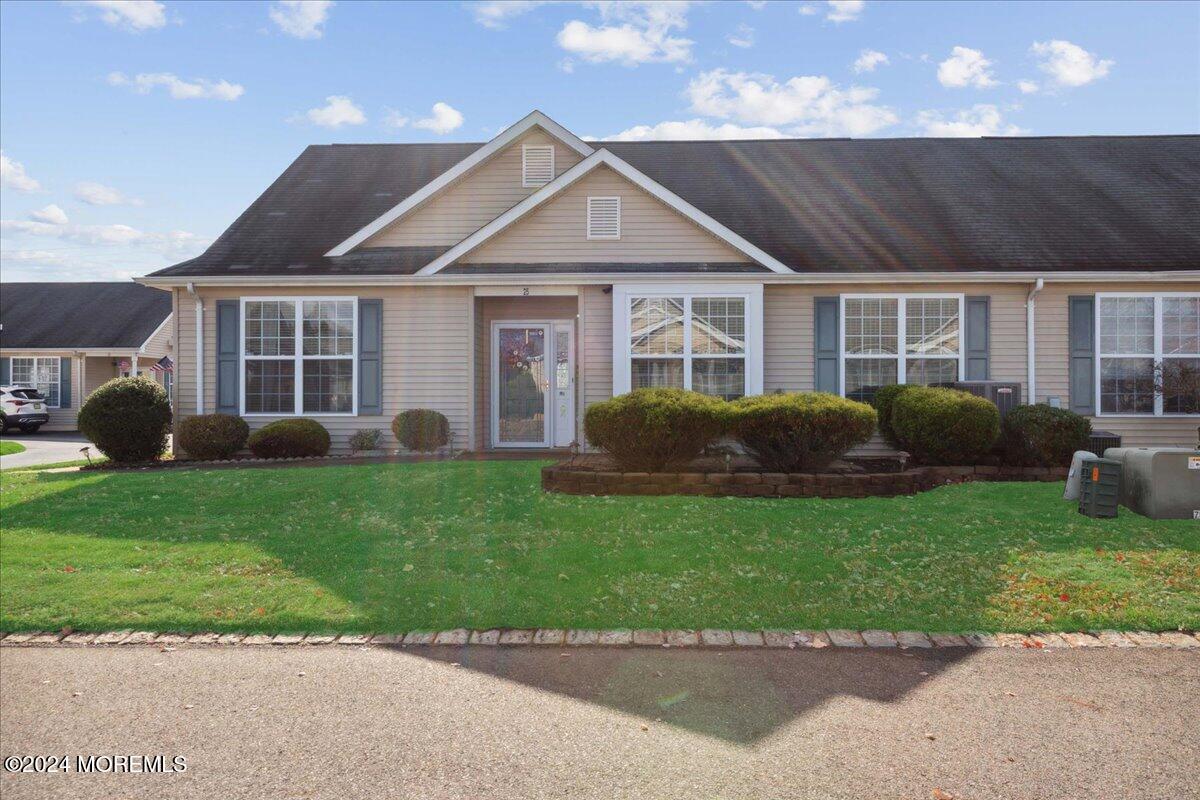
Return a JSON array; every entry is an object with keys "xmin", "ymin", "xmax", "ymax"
[{"xmin": 730, "ymin": 392, "xmax": 877, "ymax": 473}]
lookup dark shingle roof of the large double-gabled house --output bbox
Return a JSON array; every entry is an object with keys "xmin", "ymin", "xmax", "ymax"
[{"xmin": 155, "ymin": 136, "xmax": 1200, "ymax": 276}]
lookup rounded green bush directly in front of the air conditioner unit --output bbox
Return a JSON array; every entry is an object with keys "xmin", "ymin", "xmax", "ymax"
[{"xmin": 892, "ymin": 386, "xmax": 1000, "ymax": 464}]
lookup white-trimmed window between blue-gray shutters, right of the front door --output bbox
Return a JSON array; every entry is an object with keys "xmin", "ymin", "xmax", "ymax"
[{"xmin": 841, "ymin": 295, "xmax": 962, "ymax": 403}]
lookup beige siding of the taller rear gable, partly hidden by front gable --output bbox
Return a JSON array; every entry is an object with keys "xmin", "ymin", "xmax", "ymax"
[{"xmin": 361, "ymin": 128, "xmax": 581, "ymax": 248}]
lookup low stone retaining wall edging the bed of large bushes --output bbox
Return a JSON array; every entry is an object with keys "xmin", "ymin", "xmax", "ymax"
[{"xmin": 541, "ymin": 463, "xmax": 1067, "ymax": 498}]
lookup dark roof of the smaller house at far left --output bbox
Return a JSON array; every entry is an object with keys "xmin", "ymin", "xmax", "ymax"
[{"xmin": 0, "ymin": 281, "xmax": 170, "ymax": 350}]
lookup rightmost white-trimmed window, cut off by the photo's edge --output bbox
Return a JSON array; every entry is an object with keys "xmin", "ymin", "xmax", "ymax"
[{"xmin": 1096, "ymin": 293, "xmax": 1200, "ymax": 416}]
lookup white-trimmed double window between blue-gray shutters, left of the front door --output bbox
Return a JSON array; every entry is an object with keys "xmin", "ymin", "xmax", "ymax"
[{"xmin": 241, "ymin": 297, "xmax": 358, "ymax": 416}]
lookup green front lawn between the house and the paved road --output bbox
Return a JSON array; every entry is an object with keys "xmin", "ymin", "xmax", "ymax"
[{"xmin": 0, "ymin": 462, "xmax": 1200, "ymax": 632}]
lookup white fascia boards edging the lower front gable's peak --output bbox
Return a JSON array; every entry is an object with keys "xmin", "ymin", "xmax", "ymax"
[{"xmin": 416, "ymin": 150, "xmax": 792, "ymax": 276}]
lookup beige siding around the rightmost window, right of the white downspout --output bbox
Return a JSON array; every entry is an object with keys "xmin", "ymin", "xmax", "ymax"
[{"xmin": 1034, "ymin": 282, "xmax": 1200, "ymax": 447}]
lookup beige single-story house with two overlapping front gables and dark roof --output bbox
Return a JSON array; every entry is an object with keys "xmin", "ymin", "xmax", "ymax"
[{"xmin": 142, "ymin": 112, "xmax": 1200, "ymax": 450}]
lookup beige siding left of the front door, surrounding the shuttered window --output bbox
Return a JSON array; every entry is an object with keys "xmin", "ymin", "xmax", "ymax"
[{"xmin": 175, "ymin": 287, "xmax": 472, "ymax": 452}]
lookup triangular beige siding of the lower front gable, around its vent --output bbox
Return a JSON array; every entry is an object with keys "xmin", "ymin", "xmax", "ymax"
[{"xmin": 458, "ymin": 167, "xmax": 750, "ymax": 264}]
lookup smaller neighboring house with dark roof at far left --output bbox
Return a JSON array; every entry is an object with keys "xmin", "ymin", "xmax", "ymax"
[{"xmin": 0, "ymin": 281, "xmax": 174, "ymax": 431}]
